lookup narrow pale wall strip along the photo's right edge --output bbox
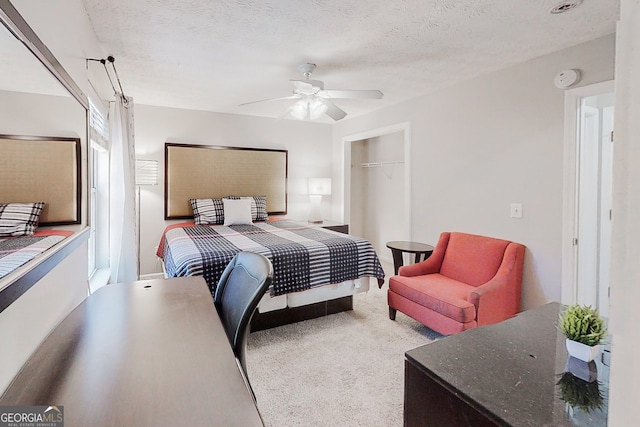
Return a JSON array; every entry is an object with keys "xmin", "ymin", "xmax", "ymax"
[{"xmin": 609, "ymin": 0, "xmax": 640, "ymax": 427}]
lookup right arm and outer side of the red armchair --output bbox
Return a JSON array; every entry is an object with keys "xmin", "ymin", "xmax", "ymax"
[{"xmin": 467, "ymin": 243, "xmax": 524, "ymax": 326}]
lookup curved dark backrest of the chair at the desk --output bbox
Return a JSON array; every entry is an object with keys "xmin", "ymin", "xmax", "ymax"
[{"xmin": 213, "ymin": 252, "xmax": 273, "ymax": 375}]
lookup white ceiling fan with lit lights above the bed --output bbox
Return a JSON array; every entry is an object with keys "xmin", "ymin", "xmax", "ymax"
[{"xmin": 240, "ymin": 63, "xmax": 383, "ymax": 121}]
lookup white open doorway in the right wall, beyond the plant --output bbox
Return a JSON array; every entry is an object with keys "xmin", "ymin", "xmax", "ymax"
[{"xmin": 562, "ymin": 82, "xmax": 615, "ymax": 317}]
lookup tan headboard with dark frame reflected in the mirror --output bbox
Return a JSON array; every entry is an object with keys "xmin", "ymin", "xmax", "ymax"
[{"xmin": 0, "ymin": 135, "xmax": 82, "ymax": 225}]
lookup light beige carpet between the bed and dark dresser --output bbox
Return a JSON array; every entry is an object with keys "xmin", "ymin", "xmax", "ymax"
[{"xmin": 247, "ymin": 266, "xmax": 440, "ymax": 427}]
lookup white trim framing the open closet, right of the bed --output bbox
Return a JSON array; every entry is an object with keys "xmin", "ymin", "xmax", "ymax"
[{"xmin": 342, "ymin": 122, "xmax": 411, "ymax": 240}]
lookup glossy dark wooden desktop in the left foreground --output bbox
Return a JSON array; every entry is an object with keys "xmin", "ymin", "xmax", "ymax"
[{"xmin": 0, "ymin": 277, "xmax": 263, "ymax": 427}]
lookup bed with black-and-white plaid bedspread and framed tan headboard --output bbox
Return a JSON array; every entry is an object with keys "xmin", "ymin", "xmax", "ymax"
[{"xmin": 157, "ymin": 143, "xmax": 384, "ymax": 330}]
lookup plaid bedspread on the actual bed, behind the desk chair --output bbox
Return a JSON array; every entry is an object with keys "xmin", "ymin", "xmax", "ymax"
[{"xmin": 163, "ymin": 221, "xmax": 384, "ymax": 296}]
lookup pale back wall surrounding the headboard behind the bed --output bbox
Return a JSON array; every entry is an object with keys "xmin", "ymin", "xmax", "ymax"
[{"xmin": 134, "ymin": 105, "xmax": 332, "ymax": 274}]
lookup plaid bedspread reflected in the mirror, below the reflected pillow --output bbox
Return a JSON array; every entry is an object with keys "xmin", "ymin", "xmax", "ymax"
[{"xmin": 0, "ymin": 235, "xmax": 65, "ymax": 279}]
